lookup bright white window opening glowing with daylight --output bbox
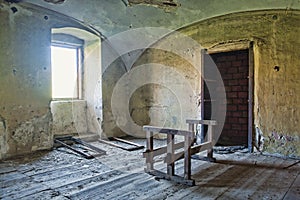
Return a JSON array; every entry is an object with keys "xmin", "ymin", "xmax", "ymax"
[{"xmin": 51, "ymin": 46, "xmax": 78, "ymax": 98}]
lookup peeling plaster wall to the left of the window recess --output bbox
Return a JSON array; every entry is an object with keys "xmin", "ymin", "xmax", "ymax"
[{"xmin": 0, "ymin": 0, "xmax": 101, "ymax": 159}]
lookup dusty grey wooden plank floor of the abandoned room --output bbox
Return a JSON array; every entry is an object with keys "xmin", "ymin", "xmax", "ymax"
[{"xmin": 0, "ymin": 141, "xmax": 300, "ymax": 200}]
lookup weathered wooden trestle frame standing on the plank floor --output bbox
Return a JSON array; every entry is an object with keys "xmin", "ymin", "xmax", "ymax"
[{"xmin": 143, "ymin": 120, "xmax": 216, "ymax": 186}]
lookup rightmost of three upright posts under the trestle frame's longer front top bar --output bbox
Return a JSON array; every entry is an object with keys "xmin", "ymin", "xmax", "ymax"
[{"xmin": 184, "ymin": 135, "xmax": 191, "ymax": 180}]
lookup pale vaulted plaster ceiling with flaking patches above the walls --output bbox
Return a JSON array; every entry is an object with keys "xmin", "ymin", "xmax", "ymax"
[{"xmin": 22, "ymin": 0, "xmax": 300, "ymax": 37}]
